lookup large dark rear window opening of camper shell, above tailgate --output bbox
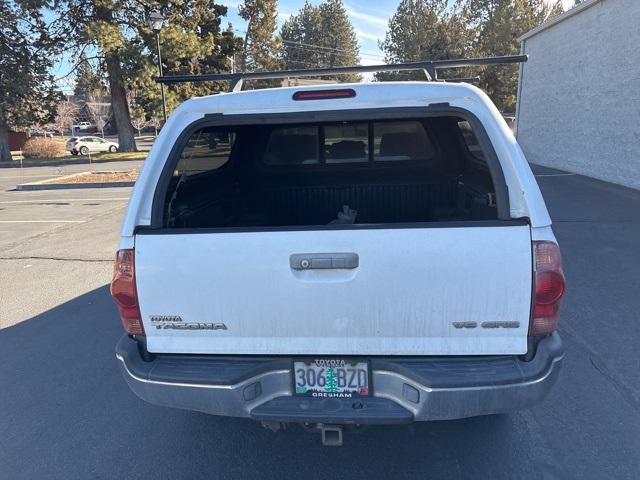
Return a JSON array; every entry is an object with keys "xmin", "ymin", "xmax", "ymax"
[{"xmin": 154, "ymin": 109, "xmax": 508, "ymax": 230}]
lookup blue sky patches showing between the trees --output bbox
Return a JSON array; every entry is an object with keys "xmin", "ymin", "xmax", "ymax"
[{"xmin": 53, "ymin": 0, "xmax": 574, "ymax": 93}]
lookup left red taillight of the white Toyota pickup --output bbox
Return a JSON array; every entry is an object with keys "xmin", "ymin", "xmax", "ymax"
[{"xmin": 111, "ymin": 249, "xmax": 144, "ymax": 335}]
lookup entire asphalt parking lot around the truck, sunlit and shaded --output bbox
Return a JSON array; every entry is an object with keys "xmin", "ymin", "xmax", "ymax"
[{"xmin": 0, "ymin": 162, "xmax": 640, "ymax": 479}]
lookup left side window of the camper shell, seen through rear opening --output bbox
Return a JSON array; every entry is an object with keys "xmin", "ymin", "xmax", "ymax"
[{"xmin": 174, "ymin": 128, "xmax": 235, "ymax": 176}]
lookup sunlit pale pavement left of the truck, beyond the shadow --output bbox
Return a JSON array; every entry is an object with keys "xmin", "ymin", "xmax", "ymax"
[{"xmin": 0, "ymin": 161, "xmax": 142, "ymax": 328}]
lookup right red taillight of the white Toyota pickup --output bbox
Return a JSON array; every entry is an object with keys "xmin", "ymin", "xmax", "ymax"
[{"xmin": 529, "ymin": 240, "xmax": 565, "ymax": 336}]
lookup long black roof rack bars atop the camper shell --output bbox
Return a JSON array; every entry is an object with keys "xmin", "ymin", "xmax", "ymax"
[{"xmin": 156, "ymin": 55, "xmax": 529, "ymax": 92}]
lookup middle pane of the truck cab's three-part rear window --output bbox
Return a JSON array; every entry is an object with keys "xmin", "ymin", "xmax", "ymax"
[{"xmin": 324, "ymin": 122, "xmax": 369, "ymax": 163}]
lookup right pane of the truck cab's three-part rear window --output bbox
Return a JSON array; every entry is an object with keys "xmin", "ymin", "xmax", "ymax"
[{"xmin": 373, "ymin": 121, "xmax": 435, "ymax": 162}]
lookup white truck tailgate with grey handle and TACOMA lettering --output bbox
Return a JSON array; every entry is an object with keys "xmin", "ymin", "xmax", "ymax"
[{"xmin": 135, "ymin": 222, "xmax": 532, "ymax": 355}]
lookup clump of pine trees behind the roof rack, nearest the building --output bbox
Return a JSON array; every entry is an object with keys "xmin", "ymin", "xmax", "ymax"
[{"xmin": 376, "ymin": 0, "xmax": 562, "ymax": 111}]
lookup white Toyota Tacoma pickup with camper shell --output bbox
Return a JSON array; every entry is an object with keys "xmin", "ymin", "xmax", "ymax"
[{"xmin": 111, "ymin": 60, "xmax": 565, "ymax": 444}]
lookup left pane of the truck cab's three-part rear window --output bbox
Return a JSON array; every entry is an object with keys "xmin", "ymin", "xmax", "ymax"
[{"xmin": 263, "ymin": 126, "xmax": 320, "ymax": 166}]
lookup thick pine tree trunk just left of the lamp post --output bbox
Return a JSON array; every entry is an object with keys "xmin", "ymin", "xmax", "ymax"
[{"xmin": 106, "ymin": 53, "xmax": 137, "ymax": 152}]
